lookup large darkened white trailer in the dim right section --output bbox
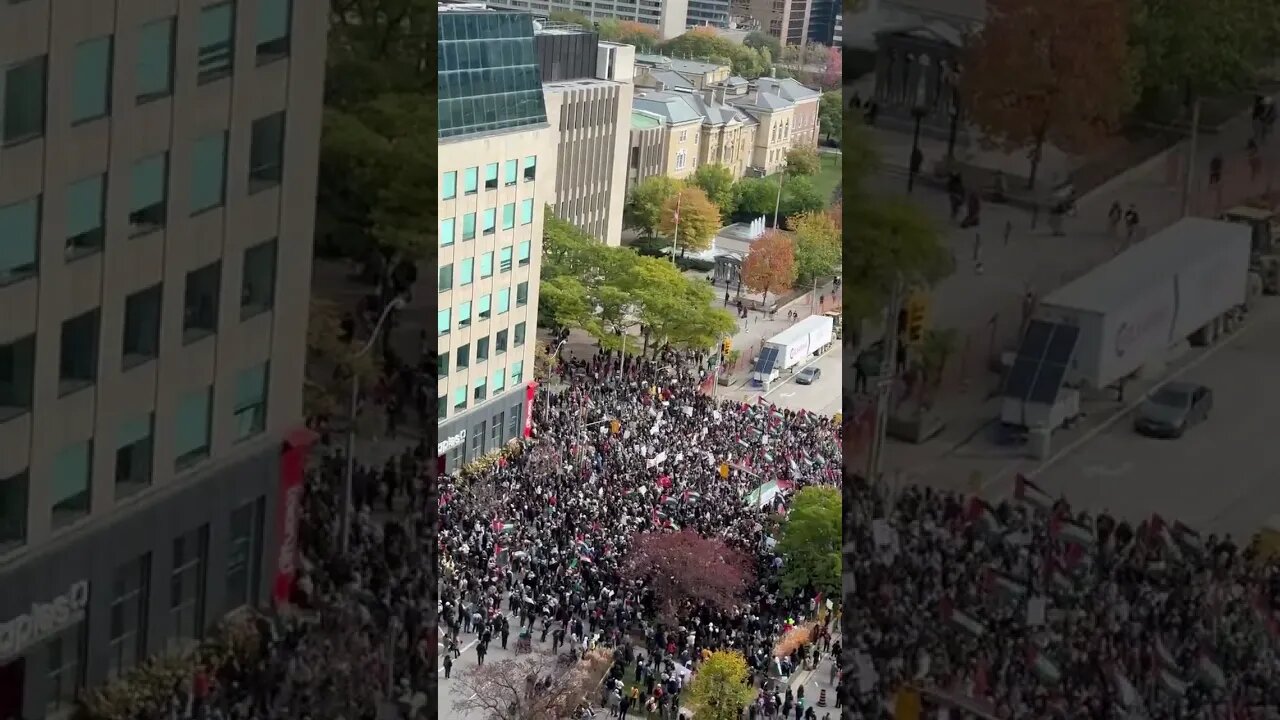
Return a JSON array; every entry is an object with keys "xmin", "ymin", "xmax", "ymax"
[{"xmin": 1036, "ymin": 218, "xmax": 1252, "ymax": 389}]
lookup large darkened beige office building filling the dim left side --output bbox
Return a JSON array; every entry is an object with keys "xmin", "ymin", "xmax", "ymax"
[{"xmin": 0, "ymin": 0, "xmax": 328, "ymax": 720}]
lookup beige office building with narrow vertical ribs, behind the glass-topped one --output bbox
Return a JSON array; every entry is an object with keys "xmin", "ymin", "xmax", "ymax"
[{"xmin": 534, "ymin": 23, "xmax": 635, "ymax": 245}]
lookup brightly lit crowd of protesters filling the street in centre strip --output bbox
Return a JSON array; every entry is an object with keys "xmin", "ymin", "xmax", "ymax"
[{"xmin": 439, "ymin": 352, "xmax": 841, "ymax": 717}]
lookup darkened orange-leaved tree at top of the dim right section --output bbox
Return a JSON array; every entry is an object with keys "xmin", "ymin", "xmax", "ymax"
[{"xmin": 960, "ymin": 0, "xmax": 1137, "ymax": 187}]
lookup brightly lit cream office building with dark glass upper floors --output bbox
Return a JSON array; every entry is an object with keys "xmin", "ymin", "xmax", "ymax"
[{"xmin": 436, "ymin": 4, "xmax": 557, "ymax": 473}]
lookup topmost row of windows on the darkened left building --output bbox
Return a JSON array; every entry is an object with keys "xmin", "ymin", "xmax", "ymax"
[{"xmin": 0, "ymin": 0, "xmax": 292, "ymax": 145}]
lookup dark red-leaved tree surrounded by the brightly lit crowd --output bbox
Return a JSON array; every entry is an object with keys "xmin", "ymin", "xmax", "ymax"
[{"xmin": 622, "ymin": 530, "xmax": 755, "ymax": 621}]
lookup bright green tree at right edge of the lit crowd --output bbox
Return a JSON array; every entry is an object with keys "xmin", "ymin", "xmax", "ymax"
[{"xmin": 777, "ymin": 487, "xmax": 842, "ymax": 594}]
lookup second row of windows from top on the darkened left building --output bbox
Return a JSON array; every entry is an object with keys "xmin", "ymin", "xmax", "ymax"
[{"xmin": 0, "ymin": 113, "xmax": 285, "ymax": 286}]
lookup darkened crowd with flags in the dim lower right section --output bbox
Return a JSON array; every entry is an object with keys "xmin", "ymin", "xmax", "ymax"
[{"xmin": 845, "ymin": 478, "xmax": 1280, "ymax": 720}]
